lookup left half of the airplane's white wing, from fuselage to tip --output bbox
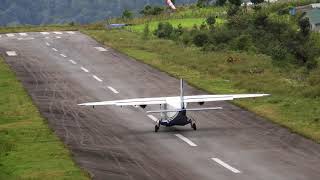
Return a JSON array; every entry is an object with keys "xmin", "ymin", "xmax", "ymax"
[{"xmin": 78, "ymin": 97, "xmax": 166, "ymax": 106}]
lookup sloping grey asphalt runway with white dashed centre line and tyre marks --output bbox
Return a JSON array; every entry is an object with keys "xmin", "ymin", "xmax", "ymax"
[{"xmin": 0, "ymin": 32, "xmax": 320, "ymax": 180}]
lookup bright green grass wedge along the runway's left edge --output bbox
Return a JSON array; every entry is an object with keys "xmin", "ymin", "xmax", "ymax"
[{"xmin": 0, "ymin": 57, "xmax": 89, "ymax": 180}]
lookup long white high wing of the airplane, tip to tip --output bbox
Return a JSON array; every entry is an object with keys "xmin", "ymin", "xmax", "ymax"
[{"xmin": 79, "ymin": 94, "xmax": 269, "ymax": 106}]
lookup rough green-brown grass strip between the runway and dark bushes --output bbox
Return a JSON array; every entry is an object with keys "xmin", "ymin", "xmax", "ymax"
[{"xmin": 84, "ymin": 30, "xmax": 320, "ymax": 143}]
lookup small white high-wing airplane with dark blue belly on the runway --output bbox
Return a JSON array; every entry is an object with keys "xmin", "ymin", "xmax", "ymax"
[{"xmin": 78, "ymin": 79, "xmax": 269, "ymax": 132}]
